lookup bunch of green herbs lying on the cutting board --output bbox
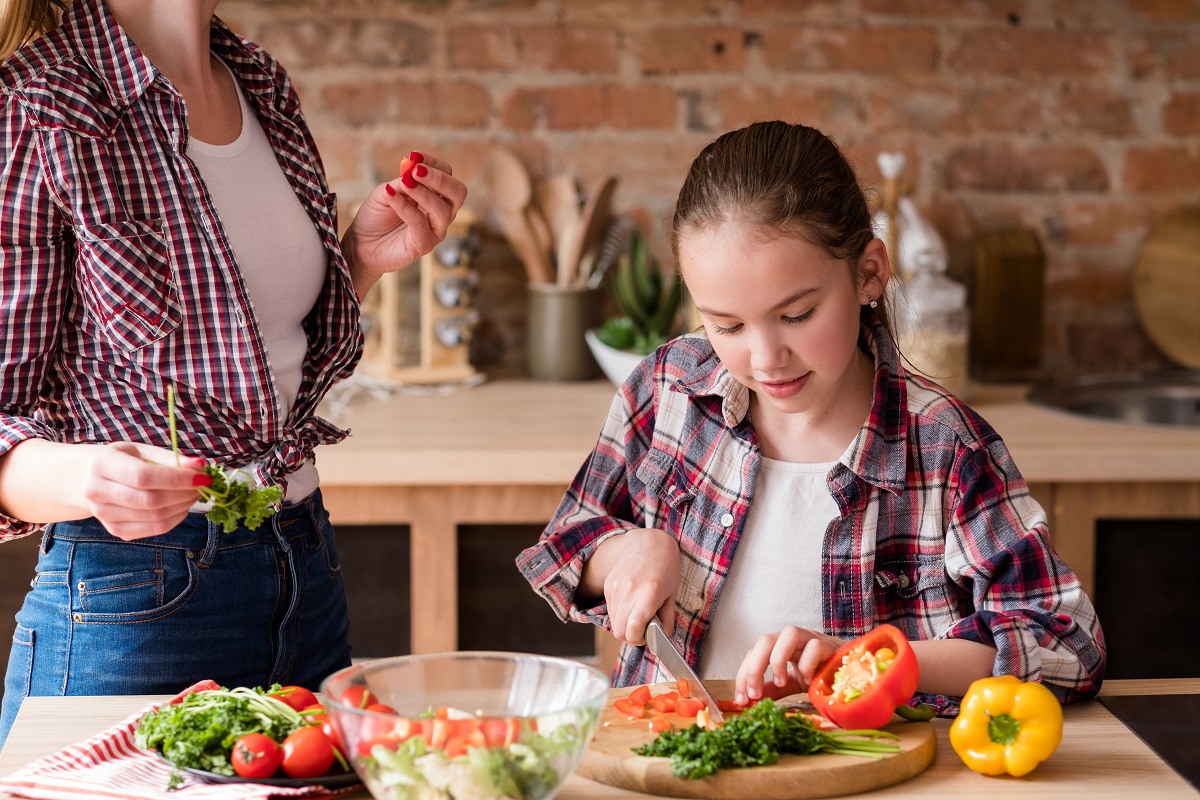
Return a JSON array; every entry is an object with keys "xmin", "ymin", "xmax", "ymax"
[{"xmin": 634, "ymin": 698, "xmax": 900, "ymax": 780}]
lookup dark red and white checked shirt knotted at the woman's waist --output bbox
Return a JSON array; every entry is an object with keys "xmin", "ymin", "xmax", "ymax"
[{"xmin": 0, "ymin": 0, "xmax": 362, "ymax": 540}]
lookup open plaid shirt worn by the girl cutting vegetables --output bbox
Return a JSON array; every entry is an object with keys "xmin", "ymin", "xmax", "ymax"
[{"xmin": 517, "ymin": 317, "xmax": 1105, "ymax": 712}]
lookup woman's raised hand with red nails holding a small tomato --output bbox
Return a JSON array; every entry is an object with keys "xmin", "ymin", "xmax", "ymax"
[{"xmin": 342, "ymin": 152, "xmax": 467, "ymax": 299}]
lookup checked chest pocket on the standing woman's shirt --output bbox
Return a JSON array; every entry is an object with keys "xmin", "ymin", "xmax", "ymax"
[{"xmin": 77, "ymin": 219, "xmax": 182, "ymax": 351}]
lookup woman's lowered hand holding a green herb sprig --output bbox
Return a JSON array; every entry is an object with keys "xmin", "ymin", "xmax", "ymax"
[{"xmin": 82, "ymin": 441, "xmax": 212, "ymax": 541}]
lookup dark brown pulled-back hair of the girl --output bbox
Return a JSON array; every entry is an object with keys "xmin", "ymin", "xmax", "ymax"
[{"xmin": 671, "ymin": 120, "xmax": 895, "ymax": 339}]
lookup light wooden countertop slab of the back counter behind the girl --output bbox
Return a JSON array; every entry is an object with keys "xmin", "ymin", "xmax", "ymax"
[{"xmin": 317, "ymin": 380, "xmax": 1200, "ymax": 487}]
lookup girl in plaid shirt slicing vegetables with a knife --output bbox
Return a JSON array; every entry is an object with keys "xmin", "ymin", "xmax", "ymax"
[{"xmin": 517, "ymin": 122, "xmax": 1104, "ymax": 712}]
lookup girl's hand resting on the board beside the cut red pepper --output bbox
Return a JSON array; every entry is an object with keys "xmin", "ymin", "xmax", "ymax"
[{"xmin": 734, "ymin": 625, "xmax": 842, "ymax": 703}]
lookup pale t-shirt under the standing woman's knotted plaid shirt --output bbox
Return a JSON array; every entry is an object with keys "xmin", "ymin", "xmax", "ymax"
[{"xmin": 187, "ymin": 61, "xmax": 329, "ymax": 503}]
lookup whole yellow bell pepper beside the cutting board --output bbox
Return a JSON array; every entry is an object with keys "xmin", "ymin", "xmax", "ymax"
[{"xmin": 950, "ymin": 675, "xmax": 1062, "ymax": 777}]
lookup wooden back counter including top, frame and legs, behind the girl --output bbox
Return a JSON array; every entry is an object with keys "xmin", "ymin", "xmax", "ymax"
[{"xmin": 317, "ymin": 380, "xmax": 1200, "ymax": 668}]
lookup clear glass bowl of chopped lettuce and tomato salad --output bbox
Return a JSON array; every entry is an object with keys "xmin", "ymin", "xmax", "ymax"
[{"xmin": 320, "ymin": 651, "xmax": 608, "ymax": 800}]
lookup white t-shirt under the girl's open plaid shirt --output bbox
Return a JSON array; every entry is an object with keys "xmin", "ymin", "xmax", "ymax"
[{"xmin": 698, "ymin": 458, "xmax": 839, "ymax": 680}]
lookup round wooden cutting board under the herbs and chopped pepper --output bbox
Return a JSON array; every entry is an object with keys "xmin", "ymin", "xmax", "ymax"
[{"xmin": 575, "ymin": 680, "xmax": 937, "ymax": 800}]
